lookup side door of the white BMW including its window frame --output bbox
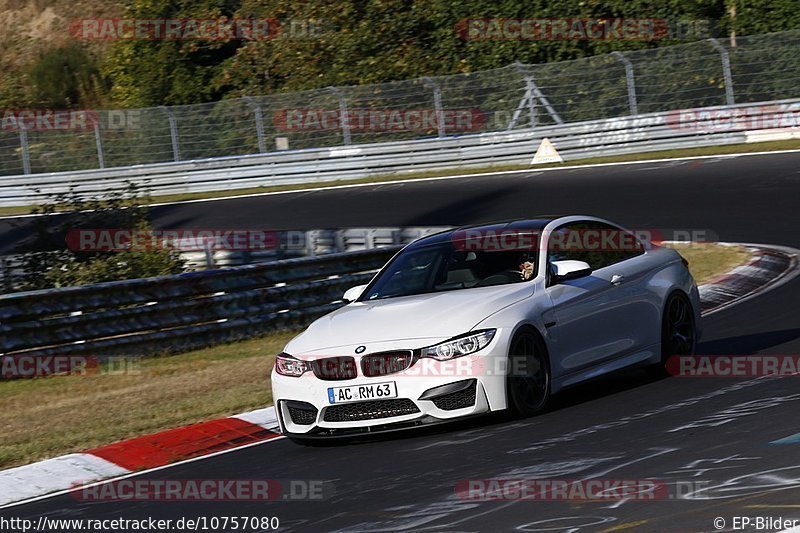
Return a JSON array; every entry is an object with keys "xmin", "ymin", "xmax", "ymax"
[{"xmin": 546, "ymin": 221, "xmax": 643, "ymax": 374}]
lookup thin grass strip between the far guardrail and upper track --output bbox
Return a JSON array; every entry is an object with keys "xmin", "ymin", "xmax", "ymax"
[{"xmin": 0, "ymin": 139, "xmax": 800, "ymax": 216}]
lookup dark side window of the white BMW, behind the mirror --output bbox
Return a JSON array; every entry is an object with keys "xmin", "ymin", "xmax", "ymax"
[{"xmin": 547, "ymin": 221, "xmax": 644, "ymax": 270}]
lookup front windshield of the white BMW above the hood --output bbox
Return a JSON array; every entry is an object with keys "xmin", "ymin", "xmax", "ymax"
[{"xmin": 362, "ymin": 242, "xmax": 536, "ymax": 300}]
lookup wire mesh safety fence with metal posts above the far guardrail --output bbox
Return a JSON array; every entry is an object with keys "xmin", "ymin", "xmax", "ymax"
[{"xmin": 0, "ymin": 30, "xmax": 800, "ymax": 175}]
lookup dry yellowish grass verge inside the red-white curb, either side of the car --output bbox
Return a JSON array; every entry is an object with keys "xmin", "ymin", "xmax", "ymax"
[{"xmin": 0, "ymin": 244, "xmax": 749, "ymax": 469}]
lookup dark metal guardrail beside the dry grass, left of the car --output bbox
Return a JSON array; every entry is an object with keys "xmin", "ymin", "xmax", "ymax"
[{"xmin": 0, "ymin": 246, "xmax": 400, "ymax": 358}]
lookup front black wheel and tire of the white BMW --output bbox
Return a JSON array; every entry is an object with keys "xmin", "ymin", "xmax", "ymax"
[{"xmin": 506, "ymin": 329, "xmax": 551, "ymax": 418}]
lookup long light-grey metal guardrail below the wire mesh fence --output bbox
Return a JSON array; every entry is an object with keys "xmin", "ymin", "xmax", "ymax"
[{"xmin": 0, "ymin": 99, "xmax": 800, "ymax": 206}]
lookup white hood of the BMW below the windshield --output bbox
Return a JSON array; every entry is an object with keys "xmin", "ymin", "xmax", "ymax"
[{"xmin": 285, "ymin": 283, "xmax": 533, "ymax": 355}]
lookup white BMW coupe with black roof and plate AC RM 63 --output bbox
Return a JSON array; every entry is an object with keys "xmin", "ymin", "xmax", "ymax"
[{"xmin": 272, "ymin": 216, "xmax": 700, "ymax": 442}]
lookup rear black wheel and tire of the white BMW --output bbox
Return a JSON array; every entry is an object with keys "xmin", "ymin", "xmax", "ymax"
[{"xmin": 653, "ymin": 292, "xmax": 697, "ymax": 376}]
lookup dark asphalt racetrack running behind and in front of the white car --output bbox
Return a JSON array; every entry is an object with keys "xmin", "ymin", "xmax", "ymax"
[{"xmin": 0, "ymin": 153, "xmax": 800, "ymax": 532}]
